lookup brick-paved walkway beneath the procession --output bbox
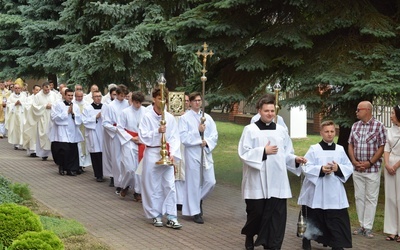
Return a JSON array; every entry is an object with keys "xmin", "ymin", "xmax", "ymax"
[{"xmin": 0, "ymin": 139, "xmax": 400, "ymax": 250}]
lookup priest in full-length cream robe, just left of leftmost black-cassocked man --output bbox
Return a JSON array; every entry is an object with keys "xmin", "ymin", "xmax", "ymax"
[{"xmin": 32, "ymin": 82, "xmax": 59, "ymax": 160}]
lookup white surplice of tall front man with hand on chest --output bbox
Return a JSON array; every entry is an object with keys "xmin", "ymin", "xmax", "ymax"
[{"xmin": 238, "ymin": 123, "xmax": 301, "ymax": 199}]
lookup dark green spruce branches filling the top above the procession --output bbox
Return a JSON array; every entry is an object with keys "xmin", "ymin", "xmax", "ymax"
[{"xmin": 0, "ymin": 0, "xmax": 400, "ymax": 127}]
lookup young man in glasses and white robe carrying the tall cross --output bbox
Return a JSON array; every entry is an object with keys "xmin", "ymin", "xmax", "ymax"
[{"xmin": 179, "ymin": 92, "xmax": 218, "ymax": 224}]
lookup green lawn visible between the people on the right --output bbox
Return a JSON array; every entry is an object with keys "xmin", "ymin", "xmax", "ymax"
[{"xmin": 213, "ymin": 122, "xmax": 385, "ymax": 232}]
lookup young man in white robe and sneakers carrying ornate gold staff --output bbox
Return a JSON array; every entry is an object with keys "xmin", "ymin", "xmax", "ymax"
[{"xmin": 139, "ymin": 87, "xmax": 182, "ymax": 229}]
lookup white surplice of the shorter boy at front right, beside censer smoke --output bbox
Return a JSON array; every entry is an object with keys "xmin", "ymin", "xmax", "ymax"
[{"xmin": 298, "ymin": 144, "xmax": 353, "ymax": 209}]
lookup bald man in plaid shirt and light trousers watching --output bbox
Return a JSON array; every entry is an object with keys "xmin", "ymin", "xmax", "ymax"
[{"xmin": 348, "ymin": 101, "xmax": 386, "ymax": 238}]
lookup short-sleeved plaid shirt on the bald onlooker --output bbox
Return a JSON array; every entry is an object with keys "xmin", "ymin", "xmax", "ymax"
[{"xmin": 348, "ymin": 117, "xmax": 386, "ymax": 173}]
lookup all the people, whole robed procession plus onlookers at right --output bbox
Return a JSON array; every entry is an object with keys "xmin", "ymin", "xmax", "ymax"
[{"xmin": 0, "ymin": 78, "xmax": 400, "ymax": 250}]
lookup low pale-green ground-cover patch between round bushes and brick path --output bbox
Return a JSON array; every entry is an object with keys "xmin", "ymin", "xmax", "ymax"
[{"xmin": 40, "ymin": 216, "xmax": 86, "ymax": 238}]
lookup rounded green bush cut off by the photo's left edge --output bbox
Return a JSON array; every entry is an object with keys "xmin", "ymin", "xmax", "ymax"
[{"xmin": 0, "ymin": 203, "xmax": 43, "ymax": 246}]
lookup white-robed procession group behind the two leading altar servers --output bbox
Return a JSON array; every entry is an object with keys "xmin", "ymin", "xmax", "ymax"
[{"xmin": 0, "ymin": 79, "xmax": 218, "ymax": 232}]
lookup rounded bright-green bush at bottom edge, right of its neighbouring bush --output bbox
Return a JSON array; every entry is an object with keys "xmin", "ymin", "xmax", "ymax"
[{"xmin": 8, "ymin": 231, "xmax": 64, "ymax": 250}]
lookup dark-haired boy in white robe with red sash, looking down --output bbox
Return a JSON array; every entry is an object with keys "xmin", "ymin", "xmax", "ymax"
[{"xmin": 118, "ymin": 91, "xmax": 147, "ymax": 201}]
